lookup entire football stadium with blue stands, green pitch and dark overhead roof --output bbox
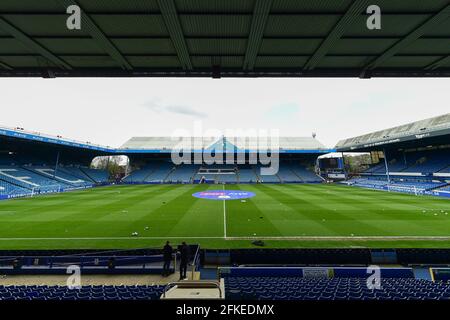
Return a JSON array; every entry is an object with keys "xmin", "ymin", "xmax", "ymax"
[{"xmin": 0, "ymin": 0, "xmax": 450, "ymax": 306}]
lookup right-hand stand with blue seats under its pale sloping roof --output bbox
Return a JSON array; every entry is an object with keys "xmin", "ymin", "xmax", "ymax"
[{"xmin": 336, "ymin": 114, "xmax": 450, "ymax": 197}]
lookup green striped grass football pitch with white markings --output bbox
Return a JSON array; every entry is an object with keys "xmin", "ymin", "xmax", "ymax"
[{"xmin": 0, "ymin": 184, "xmax": 450, "ymax": 249}]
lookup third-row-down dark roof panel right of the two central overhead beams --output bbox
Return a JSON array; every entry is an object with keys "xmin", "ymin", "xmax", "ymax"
[{"xmin": 259, "ymin": 38, "xmax": 323, "ymax": 55}]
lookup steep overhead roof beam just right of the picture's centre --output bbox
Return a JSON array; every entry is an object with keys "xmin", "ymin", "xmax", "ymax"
[{"xmin": 243, "ymin": 0, "xmax": 272, "ymax": 70}]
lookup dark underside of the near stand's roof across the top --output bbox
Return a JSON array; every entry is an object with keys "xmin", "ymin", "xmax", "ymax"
[{"xmin": 0, "ymin": 0, "xmax": 450, "ymax": 77}]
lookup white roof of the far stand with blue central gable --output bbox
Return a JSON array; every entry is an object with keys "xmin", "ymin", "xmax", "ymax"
[{"xmin": 119, "ymin": 137, "xmax": 330, "ymax": 153}]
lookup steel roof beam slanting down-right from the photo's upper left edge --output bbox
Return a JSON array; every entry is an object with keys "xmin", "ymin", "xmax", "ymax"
[{"xmin": 0, "ymin": 17, "xmax": 72, "ymax": 70}]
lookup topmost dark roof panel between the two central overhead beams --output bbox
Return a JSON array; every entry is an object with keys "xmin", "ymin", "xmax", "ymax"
[{"xmin": 175, "ymin": 0, "xmax": 255, "ymax": 13}]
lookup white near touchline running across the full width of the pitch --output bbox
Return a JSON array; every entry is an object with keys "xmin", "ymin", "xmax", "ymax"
[{"xmin": 0, "ymin": 236, "xmax": 450, "ymax": 241}]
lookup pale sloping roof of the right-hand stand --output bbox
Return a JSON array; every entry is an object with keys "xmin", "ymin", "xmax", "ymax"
[{"xmin": 335, "ymin": 113, "xmax": 450, "ymax": 151}]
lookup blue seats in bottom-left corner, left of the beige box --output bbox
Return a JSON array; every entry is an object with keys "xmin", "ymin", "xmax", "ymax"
[{"xmin": 0, "ymin": 285, "xmax": 164, "ymax": 301}]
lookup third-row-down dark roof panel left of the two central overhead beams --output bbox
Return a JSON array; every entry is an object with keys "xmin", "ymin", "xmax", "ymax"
[{"xmin": 111, "ymin": 38, "xmax": 176, "ymax": 55}]
